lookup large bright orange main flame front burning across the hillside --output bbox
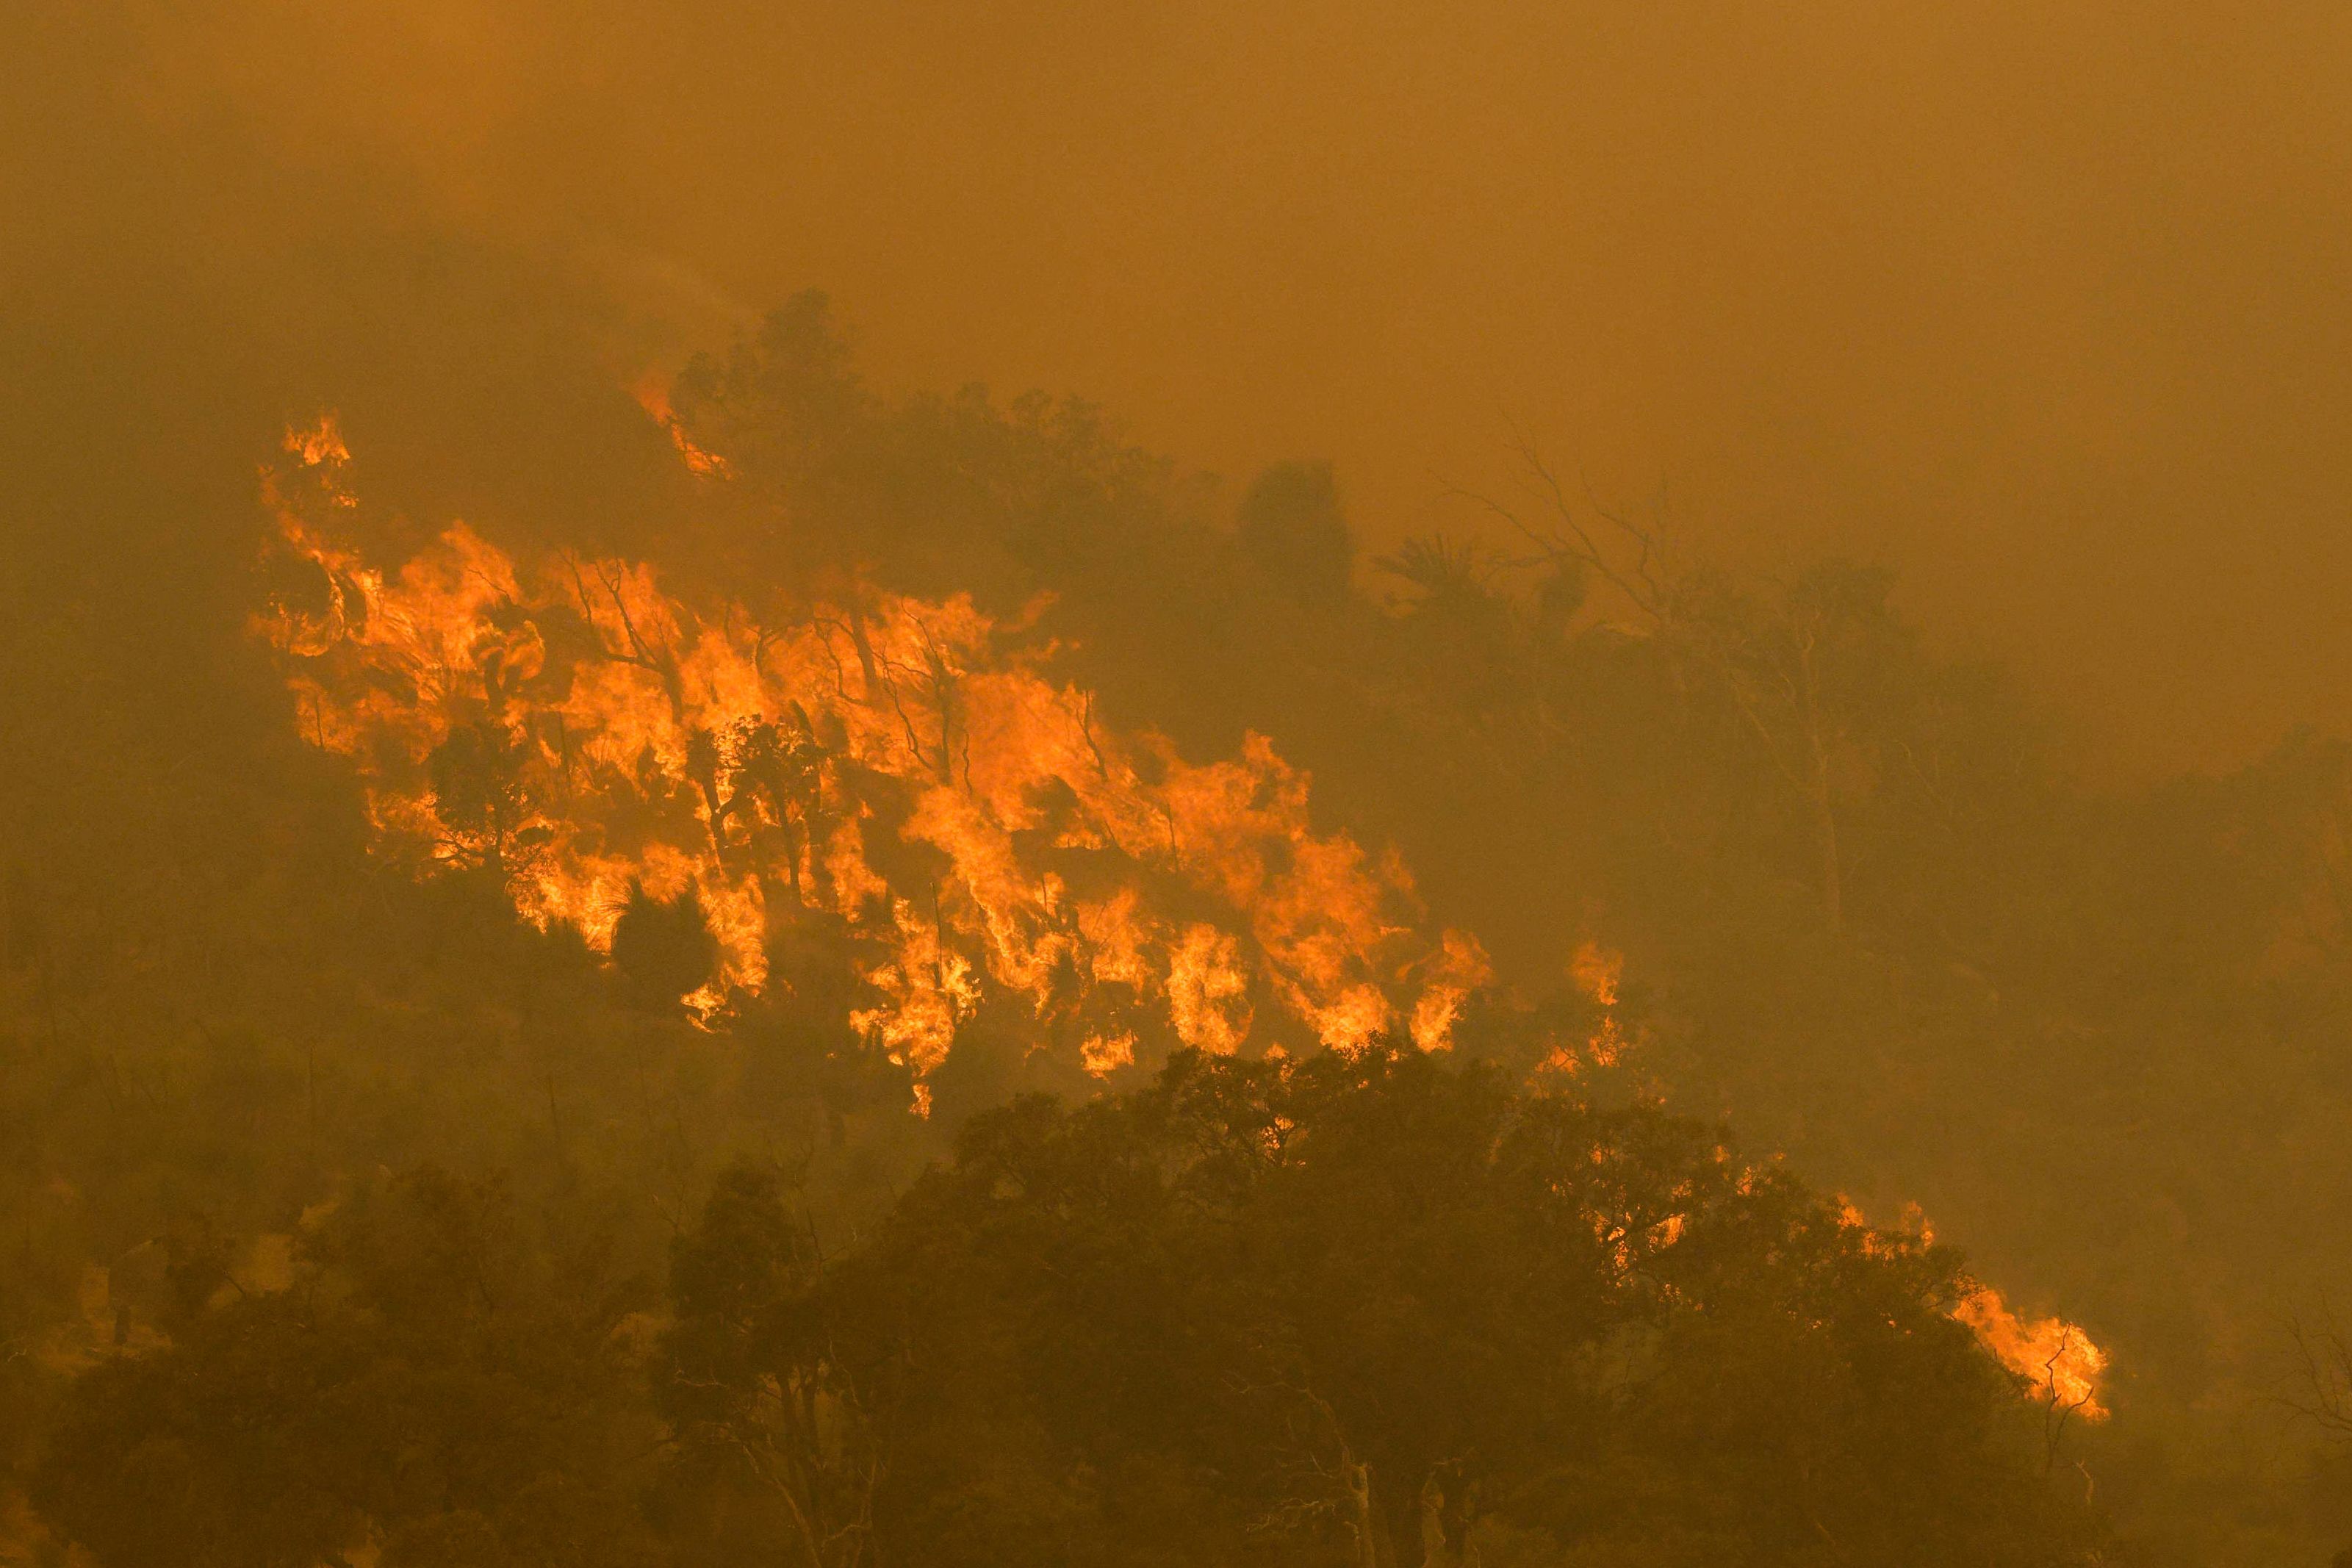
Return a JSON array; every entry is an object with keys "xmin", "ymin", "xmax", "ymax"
[{"xmin": 266, "ymin": 421, "xmax": 1489, "ymax": 1105}]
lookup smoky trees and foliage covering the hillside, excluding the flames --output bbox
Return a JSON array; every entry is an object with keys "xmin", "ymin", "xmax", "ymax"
[{"xmin": 0, "ymin": 298, "xmax": 2352, "ymax": 1564}]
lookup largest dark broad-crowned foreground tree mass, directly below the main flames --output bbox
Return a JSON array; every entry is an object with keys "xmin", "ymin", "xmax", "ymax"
[{"xmin": 840, "ymin": 1049, "xmax": 2091, "ymax": 1568}]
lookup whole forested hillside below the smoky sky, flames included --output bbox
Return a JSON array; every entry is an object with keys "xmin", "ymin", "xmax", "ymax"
[{"xmin": 0, "ymin": 296, "xmax": 2352, "ymax": 1568}]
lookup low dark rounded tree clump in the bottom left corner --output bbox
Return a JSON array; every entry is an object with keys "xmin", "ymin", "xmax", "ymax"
[{"xmin": 33, "ymin": 1168, "xmax": 656, "ymax": 1568}]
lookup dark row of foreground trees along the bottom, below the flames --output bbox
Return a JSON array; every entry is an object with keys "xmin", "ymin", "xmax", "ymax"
[{"xmin": 31, "ymin": 1049, "xmax": 2096, "ymax": 1568}]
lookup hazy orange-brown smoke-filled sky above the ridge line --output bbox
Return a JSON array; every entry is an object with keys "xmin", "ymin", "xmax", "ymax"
[{"xmin": 18, "ymin": 0, "xmax": 2352, "ymax": 766}]
